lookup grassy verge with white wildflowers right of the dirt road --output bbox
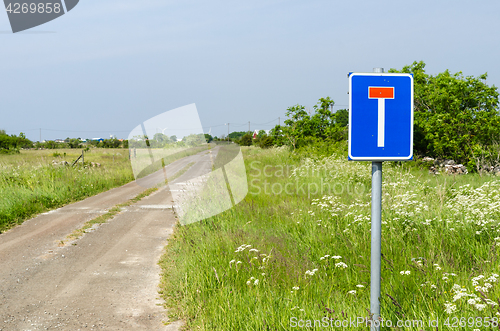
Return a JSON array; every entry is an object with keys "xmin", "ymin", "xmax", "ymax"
[{"xmin": 160, "ymin": 148, "xmax": 500, "ymax": 330}]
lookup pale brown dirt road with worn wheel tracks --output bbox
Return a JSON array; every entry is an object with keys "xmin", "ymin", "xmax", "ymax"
[{"xmin": 0, "ymin": 152, "xmax": 218, "ymax": 331}]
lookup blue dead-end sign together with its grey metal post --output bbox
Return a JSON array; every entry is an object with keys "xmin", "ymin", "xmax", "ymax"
[{"xmin": 349, "ymin": 68, "xmax": 413, "ymax": 331}]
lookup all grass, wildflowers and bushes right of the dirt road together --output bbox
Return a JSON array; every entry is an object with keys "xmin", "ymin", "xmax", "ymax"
[{"xmin": 160, "ymin": 62, "xmax": 500, "ymax": 330}]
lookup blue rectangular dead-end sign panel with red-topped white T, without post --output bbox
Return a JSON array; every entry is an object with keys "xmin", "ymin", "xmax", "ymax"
[{"xmin": 349, "ymin": 73, "xmax": 413, "ymax": 161}]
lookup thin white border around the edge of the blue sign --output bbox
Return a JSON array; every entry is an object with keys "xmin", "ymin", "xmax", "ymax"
[{"xmin": 348, "ymin": 72, "xmax": 414, "ymax": 161}]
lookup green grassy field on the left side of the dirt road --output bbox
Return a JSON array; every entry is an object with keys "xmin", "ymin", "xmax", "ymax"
[{"xmin": 0, "ymin": 149, "xmax": 134, "ymax": 232}]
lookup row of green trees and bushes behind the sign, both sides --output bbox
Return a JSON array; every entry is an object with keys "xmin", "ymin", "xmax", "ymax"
[{"xmin": 235, "ymin": 61, "xmax": 500, "ymax": 171}]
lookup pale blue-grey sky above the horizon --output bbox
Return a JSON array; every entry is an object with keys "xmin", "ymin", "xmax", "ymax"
[{"xmin": 0, "ymin": 0, "xmax": 500, "ymax": 140}]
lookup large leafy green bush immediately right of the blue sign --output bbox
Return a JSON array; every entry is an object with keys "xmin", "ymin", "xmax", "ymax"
[{"xmin": 390, "ymin": 61, "xmax": 500, "ymax": 170}]
